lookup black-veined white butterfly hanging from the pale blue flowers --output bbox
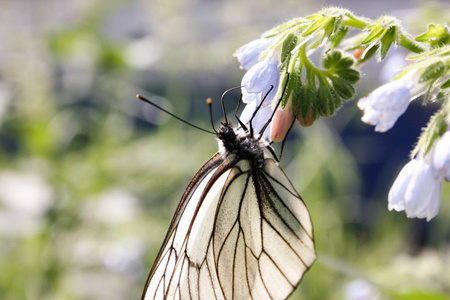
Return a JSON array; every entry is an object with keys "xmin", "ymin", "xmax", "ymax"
[{"xmin": 138, "ymin": 85, "xmax": 316, "ymax": 300}]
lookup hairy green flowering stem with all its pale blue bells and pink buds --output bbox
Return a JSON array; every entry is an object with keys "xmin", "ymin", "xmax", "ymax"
[{"xmin": 235, "ymin": 7, "xmax": 450, "ymax": 220}]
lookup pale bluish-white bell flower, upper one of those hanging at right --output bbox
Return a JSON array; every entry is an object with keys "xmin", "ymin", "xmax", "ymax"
[{"xmin": 358, "ymin": 72, "xmax": 422, "ymax": 132}]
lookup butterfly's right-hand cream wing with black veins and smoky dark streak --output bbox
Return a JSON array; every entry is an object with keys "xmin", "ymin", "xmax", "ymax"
[{"xmin": 214, "ymin": 159, "xmax": 316, "ymax": 299}]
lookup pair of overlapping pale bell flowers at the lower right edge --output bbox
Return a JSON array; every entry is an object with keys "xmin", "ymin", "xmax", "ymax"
[{"xmin": 388, "ymin": 131, "xmax": 450, "ymax": 221}]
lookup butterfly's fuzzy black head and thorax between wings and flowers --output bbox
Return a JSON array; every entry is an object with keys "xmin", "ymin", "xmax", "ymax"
[{"xmin": 217, "ymin": 123, "xmax": 270, "ymax": 164}]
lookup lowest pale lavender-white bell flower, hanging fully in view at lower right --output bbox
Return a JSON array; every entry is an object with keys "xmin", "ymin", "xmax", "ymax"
[{"xmin": 388, "ymin": 158, "xmax": 442, "ymax": 221}]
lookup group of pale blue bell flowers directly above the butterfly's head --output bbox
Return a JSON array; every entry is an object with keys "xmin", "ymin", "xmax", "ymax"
[{"xmin": 235, "ymin": 38, "xmax": 280, "ymax": 139}]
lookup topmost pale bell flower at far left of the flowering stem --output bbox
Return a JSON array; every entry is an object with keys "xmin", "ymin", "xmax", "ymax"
[{"xmin": 234, "ymin": 38, "xmax": 274, "ymax": 70}]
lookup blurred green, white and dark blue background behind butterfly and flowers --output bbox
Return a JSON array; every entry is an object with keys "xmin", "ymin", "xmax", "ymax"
[{"xmin": 0, "ymin": 0, "xmax": 450, "ymax": 300}]
